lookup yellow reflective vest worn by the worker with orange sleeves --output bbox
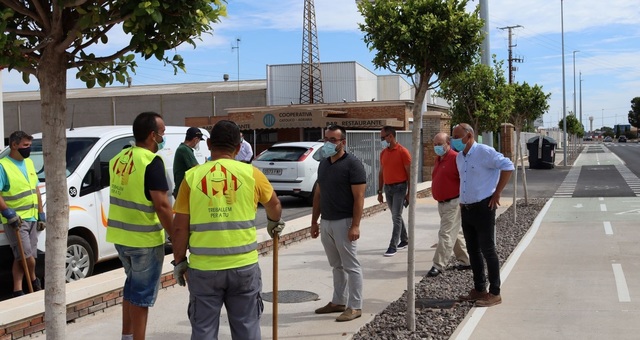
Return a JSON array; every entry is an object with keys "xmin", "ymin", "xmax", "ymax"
[{"xmin": 185, "ymin": 159, "xmax": 258, "ymax": 270}]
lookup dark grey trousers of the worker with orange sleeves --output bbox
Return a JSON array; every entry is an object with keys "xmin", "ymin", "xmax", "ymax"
[{"xmin": 187, "ymin": 263, "xmax": 264, "ymax": 340}]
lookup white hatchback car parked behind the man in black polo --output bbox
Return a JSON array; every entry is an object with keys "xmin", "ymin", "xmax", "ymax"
[{"xmin": 251, "ymin": 142, "xmax": 324, "ymax": 203}]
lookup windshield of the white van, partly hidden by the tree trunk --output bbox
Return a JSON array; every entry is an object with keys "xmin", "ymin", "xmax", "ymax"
[{"xmin": 0, "ymin": 138, "xmax": 98, "ymax": 182}]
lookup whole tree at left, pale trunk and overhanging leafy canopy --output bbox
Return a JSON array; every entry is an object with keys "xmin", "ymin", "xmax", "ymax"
[{"xmin": 0, "ymin": 0, "xmax": 226, "ymax": 340}]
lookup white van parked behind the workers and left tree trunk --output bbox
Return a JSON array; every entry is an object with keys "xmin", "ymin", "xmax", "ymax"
[{"xmin": 0, "ymin": 126, "xmax": 209, "ymax": 282}]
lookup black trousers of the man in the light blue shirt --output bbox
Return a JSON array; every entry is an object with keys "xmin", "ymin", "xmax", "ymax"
[{"xmin": 460, "ymin": 197, "xmax": 500, "ymax": 295}]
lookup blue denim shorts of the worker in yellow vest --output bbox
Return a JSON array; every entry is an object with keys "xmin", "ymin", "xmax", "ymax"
[{"xmin": 116, "ymin": 244, "xmax": 164, "ymax": 307}]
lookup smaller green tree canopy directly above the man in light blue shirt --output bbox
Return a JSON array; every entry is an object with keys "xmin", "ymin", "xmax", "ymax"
[{"xmin": 438, "ymin": 56, "xmax": 513, "ymax": 132}]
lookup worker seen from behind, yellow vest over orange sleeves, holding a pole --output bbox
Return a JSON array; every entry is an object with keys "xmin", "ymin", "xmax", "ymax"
[{"xmin": 172, "ymin": 120, "xmax": 284, "ymax": 340}]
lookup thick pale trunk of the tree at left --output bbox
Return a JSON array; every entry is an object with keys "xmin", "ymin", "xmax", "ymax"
[{"xmin": 37, "ymin": 43, "xmax": 69, "ymax": 340}]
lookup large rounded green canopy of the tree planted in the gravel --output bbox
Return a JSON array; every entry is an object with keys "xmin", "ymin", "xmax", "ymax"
[{"xmin": 358, "ymin": 0, "xmax": 484, "ymax": 113}]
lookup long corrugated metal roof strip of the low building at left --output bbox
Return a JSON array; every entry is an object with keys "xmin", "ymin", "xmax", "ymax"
[{"xmin": 2, "ymin": 79, "xmax": 267, "ymax": 102}]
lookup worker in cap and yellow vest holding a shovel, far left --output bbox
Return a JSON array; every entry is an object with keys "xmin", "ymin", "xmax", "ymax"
[{"xmin": 0, "ymin": 131, "xmax": 46, "ymax": 297}]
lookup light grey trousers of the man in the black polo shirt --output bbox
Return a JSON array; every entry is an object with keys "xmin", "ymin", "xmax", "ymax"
[{"xmin": 320, "ymin": 218, "xmax": 362, "ymax": 309}]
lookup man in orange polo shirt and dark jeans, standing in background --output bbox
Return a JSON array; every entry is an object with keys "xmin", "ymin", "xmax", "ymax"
[{"xmin": 378, "ymin": 126, "xmax": 411, "ymax": 257}]
